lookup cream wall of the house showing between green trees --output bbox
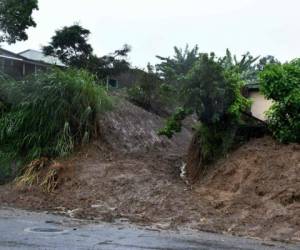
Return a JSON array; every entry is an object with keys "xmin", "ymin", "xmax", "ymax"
[{"xmin": 250, "ymin": 91, "xmax": 272, "ymax": 121}]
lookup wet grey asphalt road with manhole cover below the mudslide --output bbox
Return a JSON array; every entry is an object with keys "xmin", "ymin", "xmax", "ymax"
[{"xmin": 0, "ymin": 208, "xmax": 300, "ymax": 250}]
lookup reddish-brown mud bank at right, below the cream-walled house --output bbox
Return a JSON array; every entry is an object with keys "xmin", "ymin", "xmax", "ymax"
[{"xmin": 196, "ymin": 137, "xmax": 300, "ymax": 240}]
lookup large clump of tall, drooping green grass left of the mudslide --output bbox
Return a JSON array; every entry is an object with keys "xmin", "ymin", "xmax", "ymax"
[{"xmin": 0, "ymin": 69, "xmax": 111, "ymax": 182}]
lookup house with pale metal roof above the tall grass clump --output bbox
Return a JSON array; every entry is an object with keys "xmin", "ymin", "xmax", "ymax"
[{"xmin": 0, "ymin": 48, "xmax": 63, "ymax": 80}]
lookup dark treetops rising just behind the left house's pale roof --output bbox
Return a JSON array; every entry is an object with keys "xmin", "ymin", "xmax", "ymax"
[{"xmin": 43, "ymin": 24, "xmax": 131, "ymax": 80}]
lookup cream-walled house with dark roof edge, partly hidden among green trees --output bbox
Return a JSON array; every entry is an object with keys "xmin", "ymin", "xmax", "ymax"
[{"xmin": 244, "ymin": 83, "xmax": 273, "ymax": 121}]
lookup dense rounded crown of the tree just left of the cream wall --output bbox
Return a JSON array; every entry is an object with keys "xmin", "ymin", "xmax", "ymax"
[{"xmin": 184, "ymin": 54, "xmax": 249, "ymax": 124}]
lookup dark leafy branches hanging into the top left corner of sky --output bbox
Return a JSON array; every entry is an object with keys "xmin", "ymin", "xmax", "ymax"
[{"xmin": 0, "ymin": 0, "xmax": 38, "ymax": 44}]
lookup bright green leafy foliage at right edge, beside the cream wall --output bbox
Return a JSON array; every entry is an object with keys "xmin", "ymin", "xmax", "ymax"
[{"xmin": 260, "ymin": 59, "xmax": 300, "ymax": 143}]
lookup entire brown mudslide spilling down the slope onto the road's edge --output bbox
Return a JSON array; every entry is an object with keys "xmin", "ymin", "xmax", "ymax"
[{"xmin": 0, "ymin": 102, "xmax": 300, "ymax": 241}]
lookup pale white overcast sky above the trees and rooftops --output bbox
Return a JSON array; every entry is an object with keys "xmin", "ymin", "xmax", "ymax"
[{"xmin": 4, "ymin": 0, "xmax": 300, "ymax": 67}]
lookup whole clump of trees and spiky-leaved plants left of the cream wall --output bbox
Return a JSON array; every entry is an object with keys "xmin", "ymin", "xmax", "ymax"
[{"xmin": 128, "ymin": 46, "xmax": 278, "ymax": 171}]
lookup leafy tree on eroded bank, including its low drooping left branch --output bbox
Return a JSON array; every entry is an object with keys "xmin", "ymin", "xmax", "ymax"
[{"xmin": 160, "ymin": 53, "xmax": 249, "ymax": 181}]
